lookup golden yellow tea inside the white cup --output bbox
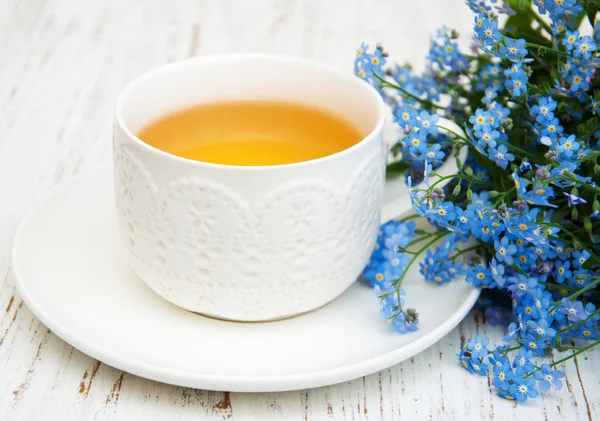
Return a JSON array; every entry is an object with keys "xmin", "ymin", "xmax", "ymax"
[{"xmin": 138, "ymin": 100, "xmax": 364, "ymax": 165}]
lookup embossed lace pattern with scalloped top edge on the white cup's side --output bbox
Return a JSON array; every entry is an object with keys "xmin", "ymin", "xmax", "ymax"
[{"xmin": 114, "ymin": 142, "xmax": 384, "ymax": 320}]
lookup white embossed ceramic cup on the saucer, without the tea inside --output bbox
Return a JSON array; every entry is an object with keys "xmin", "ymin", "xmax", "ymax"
[{"xmin": 113, "ymin": 55, "xmax": 386, "ymax": 321}]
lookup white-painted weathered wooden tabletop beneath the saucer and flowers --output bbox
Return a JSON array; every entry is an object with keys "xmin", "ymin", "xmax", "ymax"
[{"xmin": 0, "ymin": 0, "xmax": 600, "ymax": 421}]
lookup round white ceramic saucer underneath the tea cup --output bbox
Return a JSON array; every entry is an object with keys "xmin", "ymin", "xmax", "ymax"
[{"xmin": 13, "ymin": 168, "xmax": 479, "ymax": 392}]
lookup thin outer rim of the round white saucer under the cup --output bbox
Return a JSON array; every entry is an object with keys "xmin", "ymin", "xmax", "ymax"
[{"xmin": 11, "ymin": 166, "xmax": 481, "ymax": 392}]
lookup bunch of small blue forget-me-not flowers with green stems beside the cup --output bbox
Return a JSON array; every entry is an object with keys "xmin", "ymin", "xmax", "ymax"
[{"xmin": 355, "ymin": 0, "xmax": 600, "ymax": 402}]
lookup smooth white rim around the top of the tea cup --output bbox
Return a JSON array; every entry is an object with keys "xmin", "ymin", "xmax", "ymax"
[{"xmin": 115, "ymin": 53, "xmax": 385, "ymax": 171}]
